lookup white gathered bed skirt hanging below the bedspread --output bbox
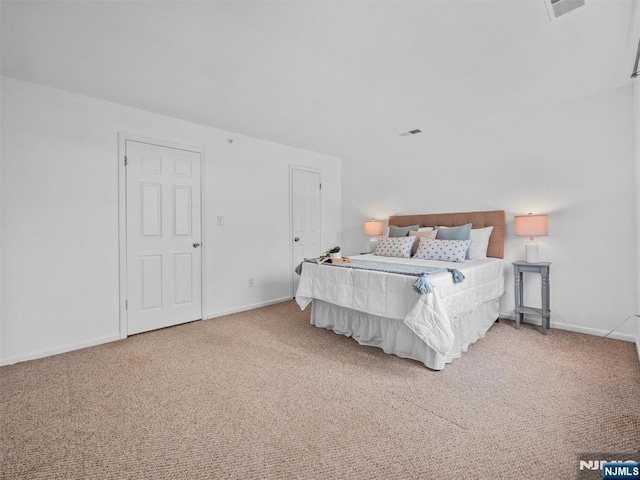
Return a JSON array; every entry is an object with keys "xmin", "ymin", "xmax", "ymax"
[{"xmin": 311, "ymin": 298, "xmax": 500, "ymax": 370}]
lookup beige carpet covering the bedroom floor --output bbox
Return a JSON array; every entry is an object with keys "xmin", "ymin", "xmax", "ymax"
[{"xmin": 0, "ymin": 302, "xmax": 640, "ymax": 479}]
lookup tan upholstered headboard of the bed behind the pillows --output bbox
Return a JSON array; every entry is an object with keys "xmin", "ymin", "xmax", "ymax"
[{"xmin": 389, "ymin": 210, "xmax": 506, "ymax": 258}]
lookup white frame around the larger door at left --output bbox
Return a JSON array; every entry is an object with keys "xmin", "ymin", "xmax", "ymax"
[{"xmin": 118, "ymin": 132, "xmax": 207, "ymax": 339}]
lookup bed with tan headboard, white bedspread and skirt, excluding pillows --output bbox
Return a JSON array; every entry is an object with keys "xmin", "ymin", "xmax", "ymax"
[{"xmin": 296, "ymin": 210, "xmax": 505, "ymax": 370}]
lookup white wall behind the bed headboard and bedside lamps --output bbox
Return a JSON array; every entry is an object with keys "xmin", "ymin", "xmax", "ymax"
[{"xmin": 342, "ymin": 86, "xmax": 638, "ymax": 340}]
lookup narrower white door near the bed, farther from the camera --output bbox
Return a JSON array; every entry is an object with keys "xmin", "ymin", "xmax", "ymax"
[{"xmin": 291, "ymin": 168, "xmax": 322, "ymax": 295}]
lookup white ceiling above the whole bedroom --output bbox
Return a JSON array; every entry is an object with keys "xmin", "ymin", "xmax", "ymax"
[{"xmin": 1, "ymin": 0, "xmax": 640, "ymax": 158}]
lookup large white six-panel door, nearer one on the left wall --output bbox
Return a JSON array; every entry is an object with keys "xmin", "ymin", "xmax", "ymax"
[{"xmin": 125, "ymin": 140, "xmax": 202, "ymax": 335}]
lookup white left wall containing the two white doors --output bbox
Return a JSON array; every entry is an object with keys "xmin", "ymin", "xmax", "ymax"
[{"xmin": 0, "ymin": 77, "xmax": 341, "ymax": 364}]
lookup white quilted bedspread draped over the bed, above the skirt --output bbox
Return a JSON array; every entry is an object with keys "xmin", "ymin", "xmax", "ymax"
[{"xmin": 296, "ymin": 255, "xmax": 504, "ymax": 357}]
